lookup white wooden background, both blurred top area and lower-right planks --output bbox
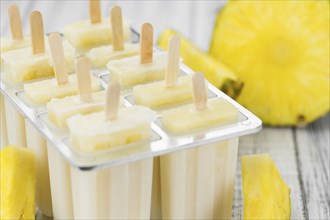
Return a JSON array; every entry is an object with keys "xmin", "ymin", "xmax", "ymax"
[{"xmin": 0, "ymin": 0, "xmax": 330, "ymax": 219}]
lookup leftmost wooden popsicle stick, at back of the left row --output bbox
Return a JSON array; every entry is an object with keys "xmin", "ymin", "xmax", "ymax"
[{"xmin": 8, "ymin": 4, "xmax": 24, "ymax": 40}]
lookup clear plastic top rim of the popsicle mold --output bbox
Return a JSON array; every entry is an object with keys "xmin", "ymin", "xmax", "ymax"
[{"xmin": 1, "ymin": 34, "xmax": 262, "ymax": 170}]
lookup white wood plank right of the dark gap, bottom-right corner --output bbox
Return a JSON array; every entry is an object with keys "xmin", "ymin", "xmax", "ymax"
[{"xmin": 295, "ymin": 114, "xmax": 330, "ymax": 219}]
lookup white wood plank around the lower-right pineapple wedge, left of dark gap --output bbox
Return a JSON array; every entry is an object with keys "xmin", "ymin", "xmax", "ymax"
[{"xmin": 232, "ymin": 127, "xmax": 304, "ymax": 219}]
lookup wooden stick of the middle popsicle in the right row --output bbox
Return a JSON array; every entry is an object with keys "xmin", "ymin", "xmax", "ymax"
[{"xmin": 140, "ymin": 23, "xmax": 153, "ymax": 64}]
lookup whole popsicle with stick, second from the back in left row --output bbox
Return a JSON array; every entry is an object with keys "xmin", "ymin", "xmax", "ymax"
[{"xmin": 1, "ymin": 11, "xmax": 75, "ymax": 83}]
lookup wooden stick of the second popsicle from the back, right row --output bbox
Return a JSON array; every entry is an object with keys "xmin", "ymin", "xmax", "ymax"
[{"xmin": 110, "ymin": 5, "xmax": 124, "ymax": 51}]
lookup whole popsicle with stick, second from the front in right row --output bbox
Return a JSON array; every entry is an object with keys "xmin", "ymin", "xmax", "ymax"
[{"xmin": 133, "ymin": 36, "xmax": 192, "ymax": 108}]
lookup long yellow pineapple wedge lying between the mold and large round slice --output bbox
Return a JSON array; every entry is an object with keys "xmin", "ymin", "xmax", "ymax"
[{"xmin": 158, "ymin": 29, "xmax": 243, "ymax": 98}]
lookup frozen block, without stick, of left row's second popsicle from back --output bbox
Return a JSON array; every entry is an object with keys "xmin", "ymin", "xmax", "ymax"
[{"xmin": 1, "ymin": 41, "xmax": 75, "ymax": 83}]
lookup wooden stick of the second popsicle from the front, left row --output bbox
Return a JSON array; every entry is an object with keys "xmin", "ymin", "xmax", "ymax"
[{"xmin": 75, "ymin": 56, "xmax": 92, "ymax": 102}]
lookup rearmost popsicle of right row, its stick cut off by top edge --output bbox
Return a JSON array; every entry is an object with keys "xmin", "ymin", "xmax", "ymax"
[{"xmin": 63, "ymin": 0, "xmax": 131, "ymax": 48}]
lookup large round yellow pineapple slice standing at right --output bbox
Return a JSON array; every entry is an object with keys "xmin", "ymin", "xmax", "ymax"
[{"xmin": 209, "ymin": 0, "xmax": 330, "ymax": 126}]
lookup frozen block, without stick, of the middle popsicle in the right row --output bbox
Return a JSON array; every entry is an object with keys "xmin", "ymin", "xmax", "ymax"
[{"xmin": 107, "ymin": 52, "xmax": 167, "ymax": 86}]
